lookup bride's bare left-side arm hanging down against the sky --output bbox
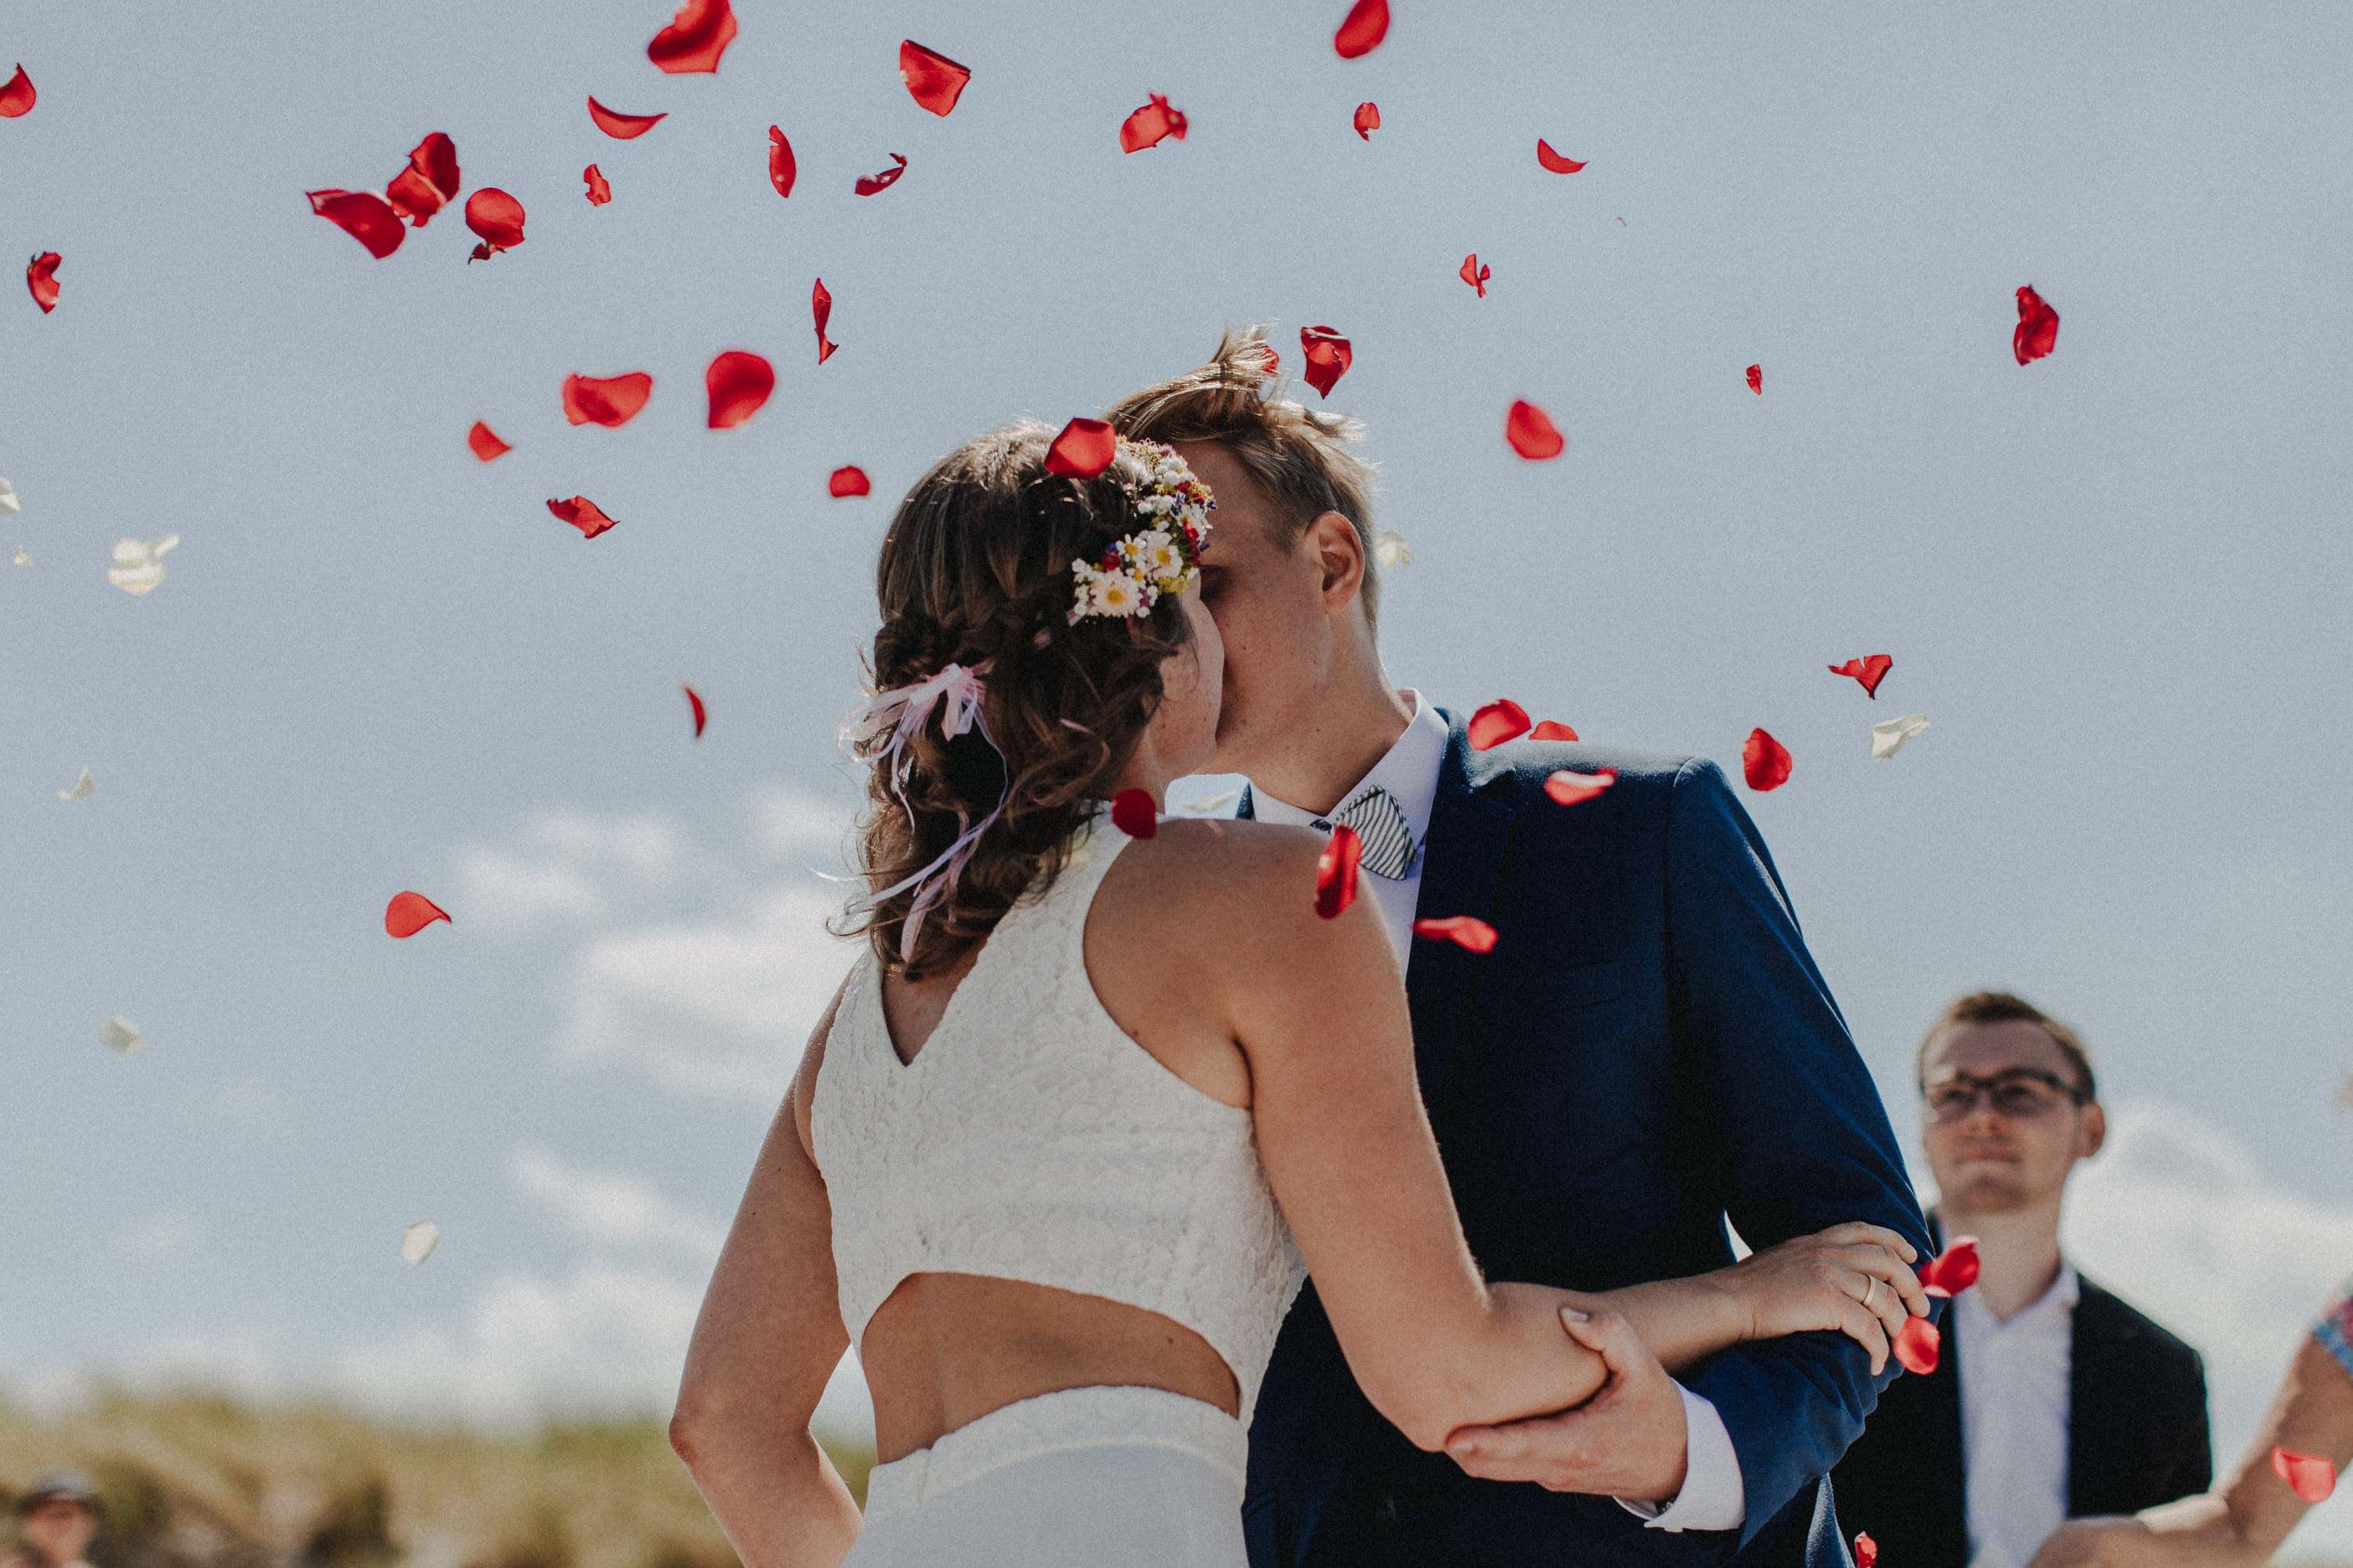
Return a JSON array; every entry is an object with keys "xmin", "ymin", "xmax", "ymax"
[{"xmin": 671, "ymin": 995, "xmax": 859, "ymax": 1568}]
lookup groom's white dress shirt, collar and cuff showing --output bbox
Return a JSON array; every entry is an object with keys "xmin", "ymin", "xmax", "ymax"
[{"xmin": 1249, "ymin": 689, "xmax": 1748, "ymax": 1530}]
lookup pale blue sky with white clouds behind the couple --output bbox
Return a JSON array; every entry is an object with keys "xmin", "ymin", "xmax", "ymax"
[{"xmin": 0, "ymin": 0, "xmax": 2353, "ymax": 1540}]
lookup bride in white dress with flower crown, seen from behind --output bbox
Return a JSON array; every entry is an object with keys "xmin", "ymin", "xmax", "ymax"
[{"xmin": 671, "ymin": 425, "xmax": 1927, "ymax": 1568}]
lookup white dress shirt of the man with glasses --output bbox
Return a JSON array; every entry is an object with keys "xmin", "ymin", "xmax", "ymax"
[{"xmin": 1953, "ymin": 1260, "xmax": 2082, "ymax": 1568}]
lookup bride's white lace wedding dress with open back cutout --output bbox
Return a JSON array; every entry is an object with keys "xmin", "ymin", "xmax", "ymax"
[{"xmin": 810, "ymin": 816, "xmax": 1303, "ymax": 1568}]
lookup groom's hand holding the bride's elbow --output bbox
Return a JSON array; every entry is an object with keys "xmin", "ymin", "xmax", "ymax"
[{"xmin": 1447, "ymin": 1307, "xmax": 1689, "ymax": 1502}]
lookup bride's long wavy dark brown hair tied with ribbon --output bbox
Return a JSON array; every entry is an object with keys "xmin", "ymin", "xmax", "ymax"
[{"xmin": 847, "ymin": 420, "xmax": 1193, "ymax": 980}]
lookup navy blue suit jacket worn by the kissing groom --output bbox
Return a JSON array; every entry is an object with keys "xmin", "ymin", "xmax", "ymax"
[{"xmin": 1242, "ymin": 715, "xmax": 1927, "ymax": 1568}]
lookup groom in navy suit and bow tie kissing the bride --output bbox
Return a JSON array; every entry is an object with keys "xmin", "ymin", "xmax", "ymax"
[{"xmin": 1111, "ymin": 329, "xmax": 1929, "ymax": 1568}]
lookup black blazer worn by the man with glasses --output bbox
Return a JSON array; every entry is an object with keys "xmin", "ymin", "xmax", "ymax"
[{"xmin": 1835, "ymin": 1279, "xmax": 2214, "ymax": 1568}]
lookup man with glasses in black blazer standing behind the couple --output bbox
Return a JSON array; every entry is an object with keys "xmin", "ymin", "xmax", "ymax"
[{"xmin": 1833, "ymin": 992, "xmax": 2214, "ymax": 1568}]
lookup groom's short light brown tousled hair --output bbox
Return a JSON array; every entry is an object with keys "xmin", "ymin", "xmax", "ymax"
[{"xmin": 1104, "ymin": 327, "xmax": 1381, "ymax": 625}]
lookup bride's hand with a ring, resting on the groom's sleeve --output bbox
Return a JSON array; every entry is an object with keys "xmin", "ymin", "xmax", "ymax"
[{"xmin": 1706, "ymin": 1220, "xmax": 1927, "ymax": 1373}]
